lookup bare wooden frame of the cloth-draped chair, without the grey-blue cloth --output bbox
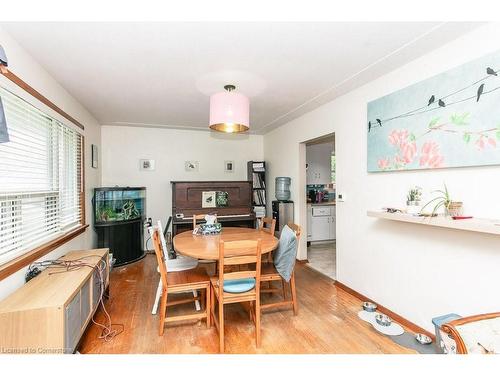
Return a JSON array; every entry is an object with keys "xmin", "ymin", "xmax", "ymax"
[{"xmin": 260, "ymin": 222, "xmax": 302, "ymax": 315}]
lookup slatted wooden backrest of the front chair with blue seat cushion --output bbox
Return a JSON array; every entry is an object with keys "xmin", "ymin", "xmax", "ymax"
[{"xmin": 219, "ymin": 239, "xmax": 262, "ymax": 298}]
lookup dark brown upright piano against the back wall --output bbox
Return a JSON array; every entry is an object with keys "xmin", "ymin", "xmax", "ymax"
[{"xmin": 171, "ymin": 181, "xmax": 256, "ymax": 236}]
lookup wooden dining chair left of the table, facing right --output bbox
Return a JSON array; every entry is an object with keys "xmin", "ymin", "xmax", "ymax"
[{"xmin": 152, "ymin": 228, "xmax": 211, "ymax": 336}]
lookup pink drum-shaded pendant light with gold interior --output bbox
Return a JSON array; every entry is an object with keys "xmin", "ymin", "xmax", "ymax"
[{"xmin": 209, "ymin": 85, "xmax": 250, "ymax": 133}]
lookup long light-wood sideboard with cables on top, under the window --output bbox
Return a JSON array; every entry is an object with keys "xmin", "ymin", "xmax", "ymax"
[{"xmin": 0, "ymin": 249, "xmax": 109, "ymax": 354}]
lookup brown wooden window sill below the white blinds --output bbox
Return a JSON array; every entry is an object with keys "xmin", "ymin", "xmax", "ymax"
[{"xmin": 0, "ymin": 224, "xmax": 88, "ymax": 280}]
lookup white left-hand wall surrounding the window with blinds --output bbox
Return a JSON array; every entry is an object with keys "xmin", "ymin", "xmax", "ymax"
[{"xmin": 0, "ymin": 28, "xmax": 101, "ymax": 300}]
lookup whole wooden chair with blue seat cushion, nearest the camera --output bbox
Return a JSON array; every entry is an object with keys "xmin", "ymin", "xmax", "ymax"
[{"xmin": 210, "ymin": 239, "xmax": 262, "ymax": 353}]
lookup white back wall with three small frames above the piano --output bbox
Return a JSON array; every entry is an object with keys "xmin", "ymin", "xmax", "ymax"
[{"xmin": 102, "ymin": 126, "xmax": 264, "ymax": 238}]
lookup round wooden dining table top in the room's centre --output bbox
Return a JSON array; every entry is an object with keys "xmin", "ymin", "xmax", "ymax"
[{"xmin": 174, "ymin": 227, "xmax": 278, "ymax": 260}]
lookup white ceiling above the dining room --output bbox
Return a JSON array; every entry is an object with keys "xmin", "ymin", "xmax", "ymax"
[{"xmin": 0, "ymin": 22, "xmax": 479, "ymax": 134}]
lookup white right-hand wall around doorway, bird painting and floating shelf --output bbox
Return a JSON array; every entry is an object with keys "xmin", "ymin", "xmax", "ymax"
[{"xmin": 264, "ymin": 24, "xmax": 500, "ymax": 330}]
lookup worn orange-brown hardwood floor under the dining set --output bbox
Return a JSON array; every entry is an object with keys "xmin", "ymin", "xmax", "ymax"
[{"xmin": 79, "ymin": 255, "xmax": 415, "ymax": 354}]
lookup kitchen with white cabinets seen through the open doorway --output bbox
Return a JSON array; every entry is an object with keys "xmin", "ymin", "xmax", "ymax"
[{"xmin": 305, "ymin": 133, "xmax": 337, "ymax": 280}]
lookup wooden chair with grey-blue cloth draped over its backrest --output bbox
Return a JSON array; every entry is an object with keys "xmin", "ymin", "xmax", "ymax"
[{"xmin": 260, "ymin": 222, "xmax": 302, "ymax": 315}]
